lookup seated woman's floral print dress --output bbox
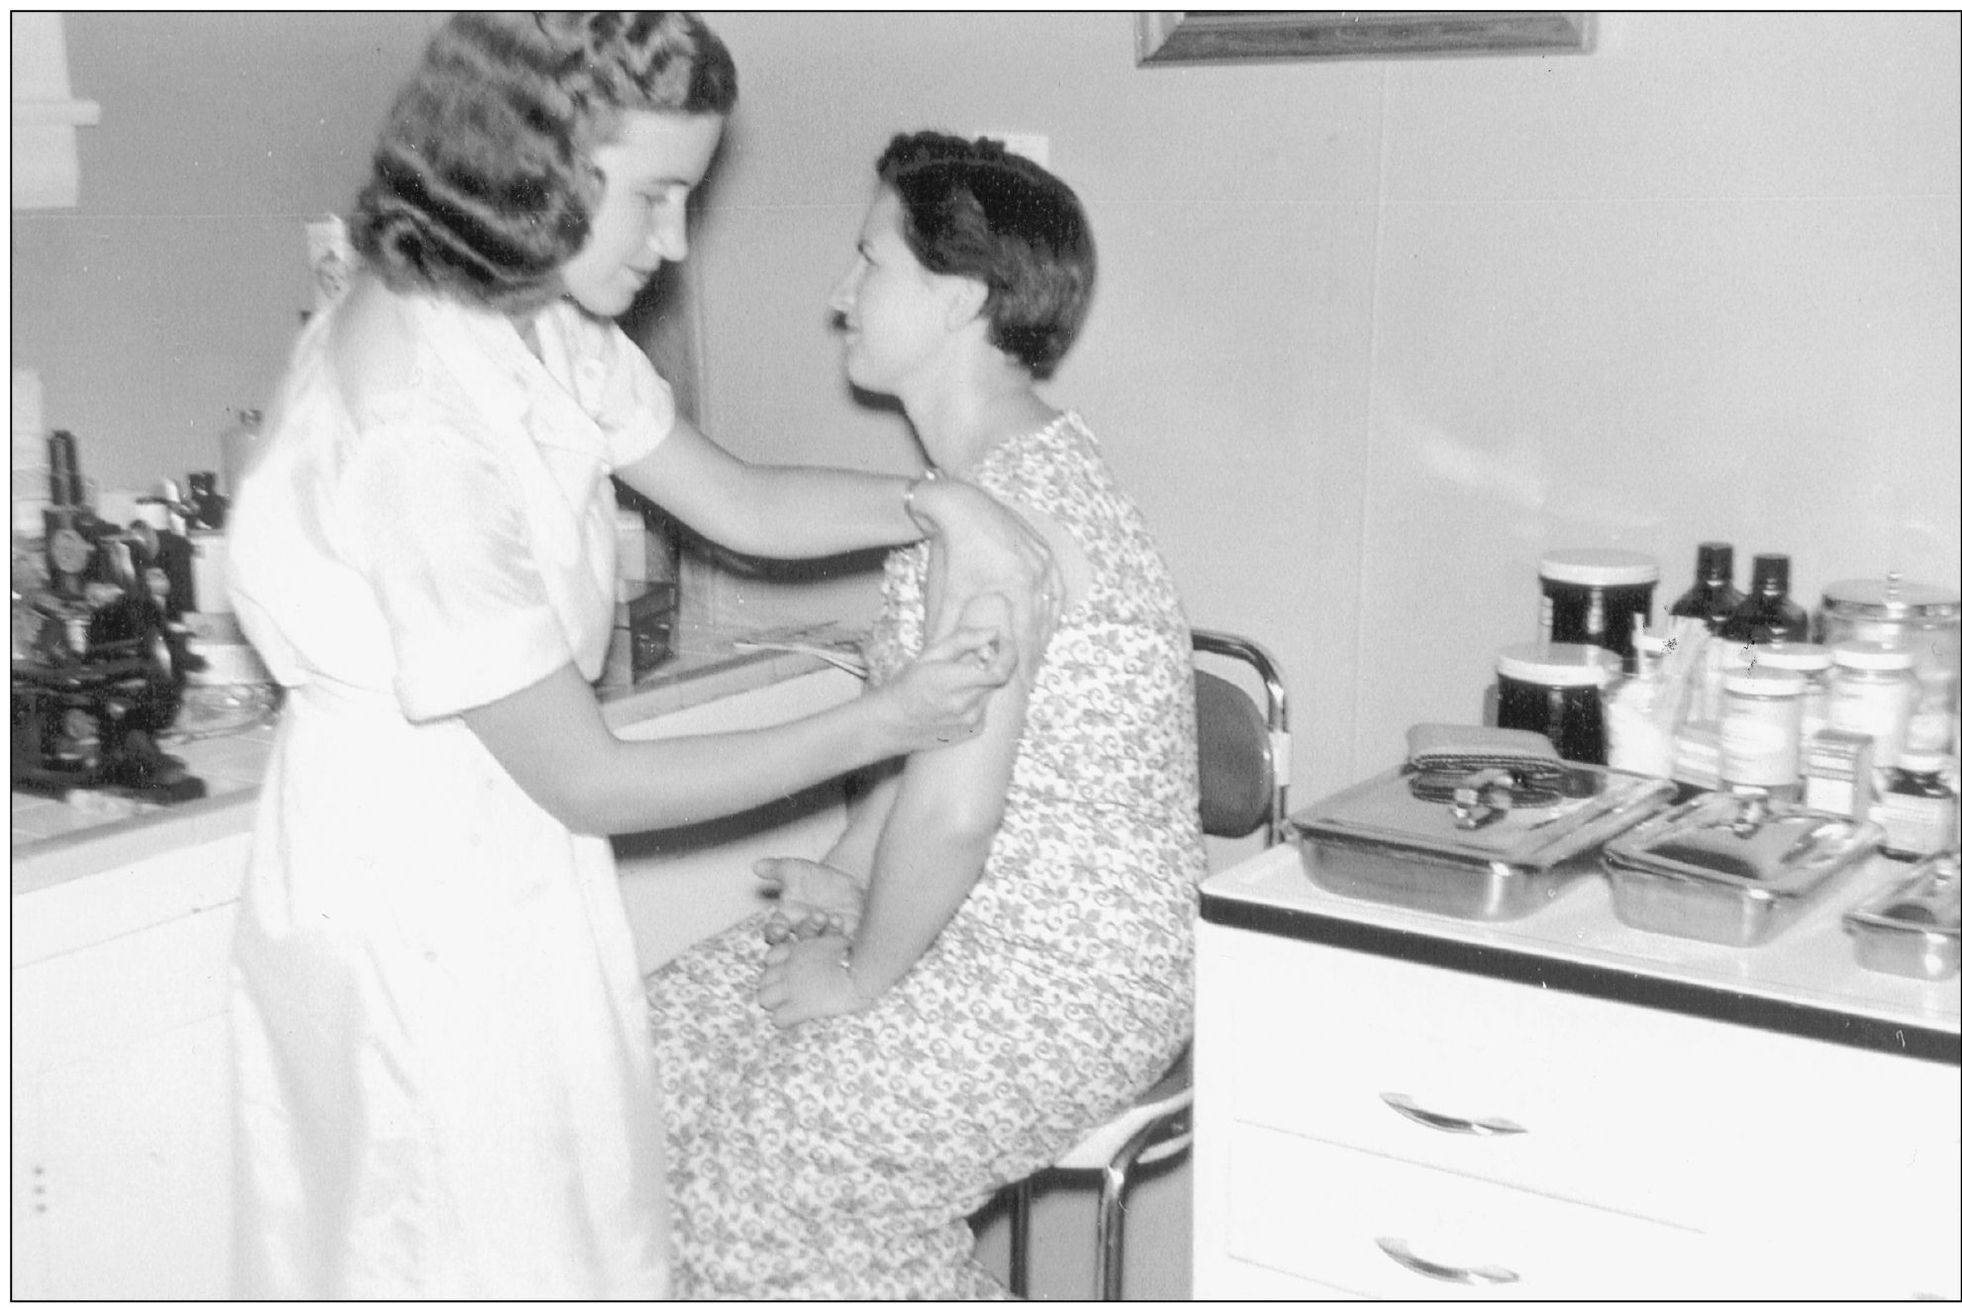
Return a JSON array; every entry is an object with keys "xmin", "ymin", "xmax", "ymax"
[{"xmin": 647, "ymin": 414, "xmax": 1205, "ymax": 1300}]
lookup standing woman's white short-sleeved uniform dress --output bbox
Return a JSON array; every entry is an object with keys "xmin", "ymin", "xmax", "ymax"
[{"xmin": 230, "ymin": 286, "xmax": 675, "ymax": 1298}]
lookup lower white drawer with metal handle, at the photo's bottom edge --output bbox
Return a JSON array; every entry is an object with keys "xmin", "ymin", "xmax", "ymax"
[{"xmin": 1226, "ymin": 1126, "xmax": 1711, "ymax": 1300}]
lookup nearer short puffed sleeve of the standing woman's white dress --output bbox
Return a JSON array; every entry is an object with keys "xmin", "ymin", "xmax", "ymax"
[{"xmin": 343, "ymin": 420, "xmax": 571, "ymax": 722}]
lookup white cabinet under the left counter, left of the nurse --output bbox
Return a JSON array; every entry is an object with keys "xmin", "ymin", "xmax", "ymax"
[{"xmin": 12, "ymin": 835, "xmax": 245, "ymax": 1300}]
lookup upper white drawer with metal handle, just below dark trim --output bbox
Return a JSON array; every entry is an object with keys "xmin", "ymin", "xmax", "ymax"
[{"xmin": 1201, "ymin": 937, "xmax": 1962, "ymax": 1230}]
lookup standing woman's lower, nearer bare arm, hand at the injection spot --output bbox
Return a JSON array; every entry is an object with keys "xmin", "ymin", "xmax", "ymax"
[{"xmin": 463, "ymin": 628, "xmax": 1014, "ymax": 835}]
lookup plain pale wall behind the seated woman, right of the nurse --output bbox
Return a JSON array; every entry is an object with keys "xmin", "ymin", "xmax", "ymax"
[{"xmin": 691, "ymin": 12, "xmax": 1962, "ymax": 802}]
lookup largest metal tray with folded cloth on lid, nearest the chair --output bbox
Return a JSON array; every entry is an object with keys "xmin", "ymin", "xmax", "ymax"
[{"xmin": 1289, "ymin": 763, "xmax": 1676, "ymax": 922}]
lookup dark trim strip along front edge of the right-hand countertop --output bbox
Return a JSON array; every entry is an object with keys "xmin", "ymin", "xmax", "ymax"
[{"xmin": 1199, "ymin": 890, "xmax": 1962, "ymax": 1067}]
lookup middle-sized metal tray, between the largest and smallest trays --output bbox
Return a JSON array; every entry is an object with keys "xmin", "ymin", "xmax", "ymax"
[{"xmin": 1601, "ymin": 794, "xmax": 1882, "ymax": 947}]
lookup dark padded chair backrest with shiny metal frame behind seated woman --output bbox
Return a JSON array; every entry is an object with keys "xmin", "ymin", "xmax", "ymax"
[{"xmin": 1193, "ymin": 630, "xmax": 1291, "ymax": 845}]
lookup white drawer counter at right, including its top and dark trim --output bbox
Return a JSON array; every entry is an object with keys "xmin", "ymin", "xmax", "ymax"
[{"xmin": 1193, "ymin": 845, "xmax": 1962, "ymax": 1300}]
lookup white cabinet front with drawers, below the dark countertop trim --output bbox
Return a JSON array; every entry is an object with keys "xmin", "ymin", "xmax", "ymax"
[{"xmin": 1193, "ymin": 924, "xmax": 1962, "ymax": 1298}]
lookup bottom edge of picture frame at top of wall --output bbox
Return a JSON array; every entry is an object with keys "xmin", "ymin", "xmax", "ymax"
[{"xmin": 1138, "ymin": 10, "xmax": 1593, "ymax": 67}]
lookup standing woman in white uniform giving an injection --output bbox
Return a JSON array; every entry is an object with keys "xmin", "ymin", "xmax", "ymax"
[{"xmin": 232, "ymin": 14, "xmax": 1054, "ymax": 1298}]
